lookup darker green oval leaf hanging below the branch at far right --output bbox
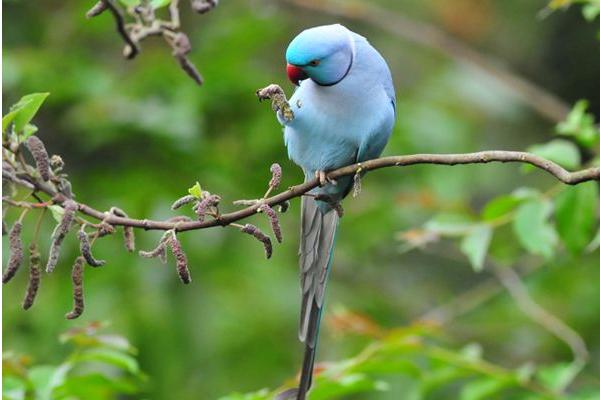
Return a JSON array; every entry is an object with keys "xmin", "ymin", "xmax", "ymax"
[{"xmin": 556, "ymin": 182, "xmax": 598, "ymax": 254}]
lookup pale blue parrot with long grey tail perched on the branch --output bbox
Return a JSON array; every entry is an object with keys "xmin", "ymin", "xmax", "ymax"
[{"xmin": 278, "ymin": 24, "xmax": 396, "ymax": 400}]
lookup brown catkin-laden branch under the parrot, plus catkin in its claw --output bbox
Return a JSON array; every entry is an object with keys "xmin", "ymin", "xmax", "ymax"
[{"xmin": 2, "ymin": 85, "xmax": 600, "ymax": 318}]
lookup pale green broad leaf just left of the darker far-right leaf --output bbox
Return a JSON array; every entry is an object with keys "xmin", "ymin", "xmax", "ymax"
[{"xmin": 513, "ymin": 199, "xmax": 558, "ymax": 258}]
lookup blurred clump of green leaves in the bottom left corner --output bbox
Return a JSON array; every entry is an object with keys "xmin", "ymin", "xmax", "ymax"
[{"xmin": 2, "ymin": 323, "xmax": 146, "ymax": 400}]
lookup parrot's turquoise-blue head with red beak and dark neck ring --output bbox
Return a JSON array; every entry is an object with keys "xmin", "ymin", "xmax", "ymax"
[{"xmin": 285, "ymin": 24, "xmax": 354, "ymax": 86}]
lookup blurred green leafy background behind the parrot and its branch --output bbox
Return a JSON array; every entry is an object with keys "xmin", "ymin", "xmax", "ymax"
[{"xmin": 3, "ymin": 0, "xmax": 600, "ymax": 399}]
